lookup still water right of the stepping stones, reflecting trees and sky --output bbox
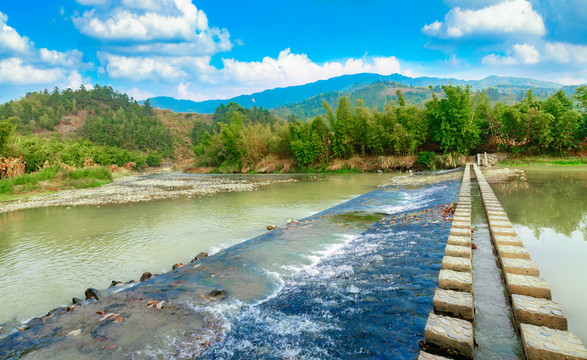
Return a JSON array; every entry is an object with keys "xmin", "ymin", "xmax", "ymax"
[{"xmin": 491, "ymin": 166, "xmax": 587, "ymax": 344}]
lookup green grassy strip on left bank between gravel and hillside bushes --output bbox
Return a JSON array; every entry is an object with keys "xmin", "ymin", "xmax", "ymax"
[{"xmin": 0, "ymin": 167, "xmax": 112, "ymax": 201}]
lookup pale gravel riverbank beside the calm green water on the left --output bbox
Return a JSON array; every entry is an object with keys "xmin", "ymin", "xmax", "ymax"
[{"xmin": 0, "ymin": 173, "xmax": 296, "ymax": 213}]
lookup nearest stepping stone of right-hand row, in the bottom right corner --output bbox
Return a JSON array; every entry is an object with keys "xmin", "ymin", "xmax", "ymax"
[{"xmin": 520, "ymin": 324, "xmax": 587, "ymax": 360}]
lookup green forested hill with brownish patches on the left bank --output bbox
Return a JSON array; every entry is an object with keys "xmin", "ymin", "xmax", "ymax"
[{"xmin": 0, "ymin": 85, "xmax": 188, "ymax": 172}]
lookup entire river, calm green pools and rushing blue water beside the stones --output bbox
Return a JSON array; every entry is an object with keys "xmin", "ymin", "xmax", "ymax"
[{"xmin": 0, "ymin": 167, "xmax": 587, "ymax": 359}]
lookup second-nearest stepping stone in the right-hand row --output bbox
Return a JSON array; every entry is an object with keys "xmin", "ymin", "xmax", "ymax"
[{"xmin": 512, "ymin": 294, "xmax": 568, "ymax": 331}]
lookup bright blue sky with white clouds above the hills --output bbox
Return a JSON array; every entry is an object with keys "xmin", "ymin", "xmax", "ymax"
[{"xmin": 0, "ymin": 0, "xmax": 587, "ymax": 102}]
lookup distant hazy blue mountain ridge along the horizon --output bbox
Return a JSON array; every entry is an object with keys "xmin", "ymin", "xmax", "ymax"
[{"xmin": 149, "ymin": 73, "xmax": 575, "ymax": 114}]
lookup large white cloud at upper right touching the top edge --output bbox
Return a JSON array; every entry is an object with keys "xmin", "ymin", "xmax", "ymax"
[{"xmin": 422, "ymin": 0, "xmax": 546, "ymax": 38}]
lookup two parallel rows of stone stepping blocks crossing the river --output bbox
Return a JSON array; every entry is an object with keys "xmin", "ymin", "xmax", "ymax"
[{"xmin": 419, "ymin": 164, "xmax": 587, "ymax": 360}]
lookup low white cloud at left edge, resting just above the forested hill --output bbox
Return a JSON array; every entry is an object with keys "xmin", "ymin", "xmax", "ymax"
[{"xmin": 0, "ymin": 58, "xmax": 65, "ymax": 84}]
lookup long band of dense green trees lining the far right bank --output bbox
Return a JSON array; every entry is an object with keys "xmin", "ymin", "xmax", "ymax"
[{"xmin": 193, "ymin": 85, "xmax": 587, "ymax": 172}]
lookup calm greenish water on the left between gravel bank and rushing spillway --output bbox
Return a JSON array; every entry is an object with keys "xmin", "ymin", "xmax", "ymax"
[{"xmin": 0, "ymin": 174, "xmax": 390, "ymax": 325}]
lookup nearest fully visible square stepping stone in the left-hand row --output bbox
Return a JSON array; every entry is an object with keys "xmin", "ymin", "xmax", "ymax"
[{"xmin": 424, "ymin": 314, "xmax": 475, "ymax": 359}]
